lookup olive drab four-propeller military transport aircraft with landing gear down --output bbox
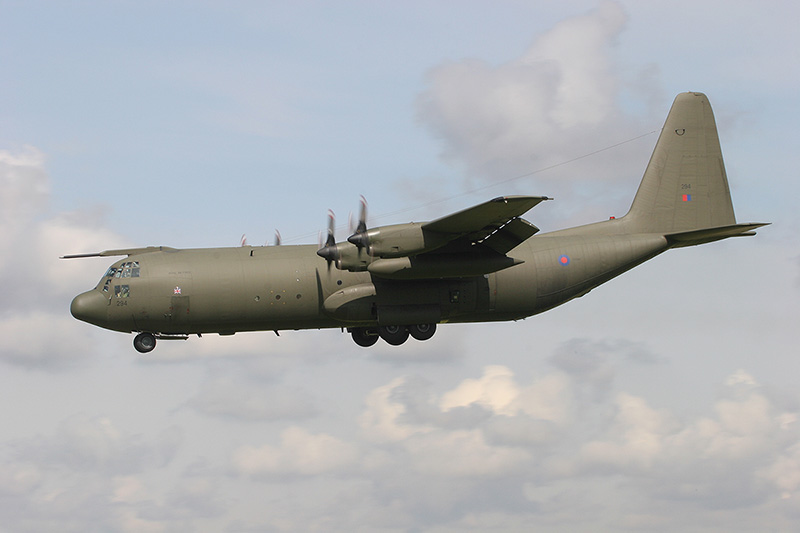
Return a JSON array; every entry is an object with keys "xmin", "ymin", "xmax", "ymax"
[{"xmin": 64, "ymin": 93, "xmax": 766, "ymax": 353}]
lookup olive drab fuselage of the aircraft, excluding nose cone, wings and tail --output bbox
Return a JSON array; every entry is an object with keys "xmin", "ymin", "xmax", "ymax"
[{"xmin": 76, "ymin": 229, "xmax": 668, "ymax": 335}]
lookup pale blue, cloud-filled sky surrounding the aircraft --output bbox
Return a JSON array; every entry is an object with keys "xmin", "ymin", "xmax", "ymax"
[{"xmin": 0, "ymin": 0, "xmax": 800, "ymax": 533}]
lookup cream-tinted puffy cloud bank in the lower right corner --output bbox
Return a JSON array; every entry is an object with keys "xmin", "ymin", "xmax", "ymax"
[{"xmin": 574, "ymin": 370, "xmax": 800, "ymax": 509}]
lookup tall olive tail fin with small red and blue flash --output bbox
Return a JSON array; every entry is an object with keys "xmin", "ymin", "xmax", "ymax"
[{"xmin": 625, "ymin": 93, "xmax": 736, "ymax": 234}]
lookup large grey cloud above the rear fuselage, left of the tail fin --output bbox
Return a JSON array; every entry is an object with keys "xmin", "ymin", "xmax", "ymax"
[{"xmin": 417, "ymin": 2, "xmax": 643, "ymax": 189}]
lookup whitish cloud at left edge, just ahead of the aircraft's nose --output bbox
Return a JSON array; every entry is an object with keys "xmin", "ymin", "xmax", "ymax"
[{"xmin": 0, "ymin": 146, "xmax": 124, "ymax": 371}]
